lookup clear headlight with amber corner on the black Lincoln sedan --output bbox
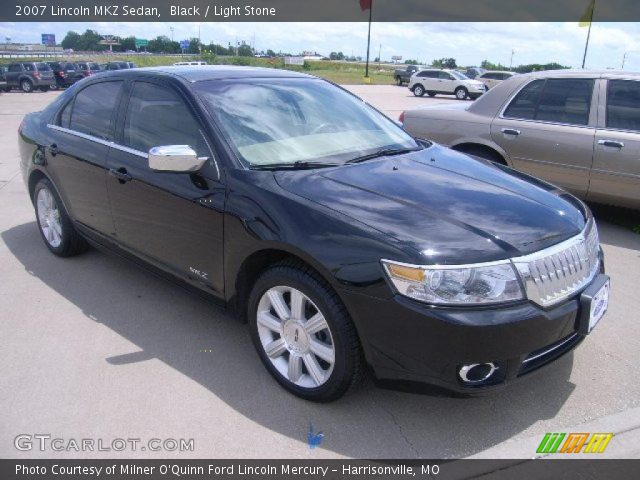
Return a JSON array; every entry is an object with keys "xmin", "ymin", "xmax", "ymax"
[{"xmin": 382, "ymin": 260, "xmax": 524, "ymax": 305}]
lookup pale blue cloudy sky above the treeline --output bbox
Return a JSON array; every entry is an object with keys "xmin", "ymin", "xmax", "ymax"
[{"xmin": 0, "ymin": 22, "xmax": 640, "ymax": 71}]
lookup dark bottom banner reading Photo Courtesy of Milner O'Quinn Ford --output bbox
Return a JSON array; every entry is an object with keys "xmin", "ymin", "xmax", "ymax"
[{"xmin": 0, "ymin": 459, "xmax": 640, "ymax": 480}]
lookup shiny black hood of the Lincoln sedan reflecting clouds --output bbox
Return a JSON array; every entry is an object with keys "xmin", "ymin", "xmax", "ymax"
[{"xmin": 275, "ymin": 145, "xmax": 585, "ymax": 264}]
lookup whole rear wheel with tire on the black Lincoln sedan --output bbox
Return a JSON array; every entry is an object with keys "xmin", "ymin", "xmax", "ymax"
[{"xmin": 33, "ymin": 178, "xmax": 88, "ymax": 257}]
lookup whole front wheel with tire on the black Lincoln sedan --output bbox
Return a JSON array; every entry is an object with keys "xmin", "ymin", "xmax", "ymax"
[{"xmin": 248, "ymin": 263, "xmax": 364, "ymax": 402}]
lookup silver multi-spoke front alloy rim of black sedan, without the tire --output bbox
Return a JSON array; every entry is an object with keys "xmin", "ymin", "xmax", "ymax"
[{"xmin": 257, "ymin": 286, "xmax": 335, "ymax": 388}]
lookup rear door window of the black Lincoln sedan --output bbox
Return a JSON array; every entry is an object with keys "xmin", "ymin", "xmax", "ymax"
[{"xmin": 69, "ymin": 80, "xmax": 122, "ymax": 140}]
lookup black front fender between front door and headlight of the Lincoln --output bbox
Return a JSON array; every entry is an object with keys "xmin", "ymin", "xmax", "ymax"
[{"xmin": 225, "ymin": 170, "xmax": 415, "ymax": 301}]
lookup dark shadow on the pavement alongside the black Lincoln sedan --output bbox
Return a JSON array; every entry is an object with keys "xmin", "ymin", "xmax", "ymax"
[{"xmin": 2, "ymin": 222, "xmax": 575, "ymax": 458}]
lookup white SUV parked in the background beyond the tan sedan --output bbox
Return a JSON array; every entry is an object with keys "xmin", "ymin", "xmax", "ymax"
[{"xmin": 409, "ymin": 68, "xmax": 487, "ymax": 100}]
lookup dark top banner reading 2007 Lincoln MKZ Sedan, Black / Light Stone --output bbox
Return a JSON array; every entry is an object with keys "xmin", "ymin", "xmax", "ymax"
[{"xmin": 0, "ymin": 0, "xmax": 640, "ymax": 22}]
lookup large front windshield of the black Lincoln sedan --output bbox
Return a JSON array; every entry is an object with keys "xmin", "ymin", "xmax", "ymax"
[{"xmin": 196, "ymin": 78, "xmax": 419, "ymax": 166}]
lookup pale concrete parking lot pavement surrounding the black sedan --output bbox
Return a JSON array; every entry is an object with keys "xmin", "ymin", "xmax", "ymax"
[{"xmin": 0, "ymin": 86, "xmax": 640, "ymax": 458}]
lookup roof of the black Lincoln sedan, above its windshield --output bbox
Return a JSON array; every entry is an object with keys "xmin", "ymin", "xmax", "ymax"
[{"xmin": 90, "ymin": 65, "xmax": 315, "ymax": 83}]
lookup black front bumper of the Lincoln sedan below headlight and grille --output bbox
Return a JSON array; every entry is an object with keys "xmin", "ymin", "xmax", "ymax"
[{"xmin": 341, "ymin": 275, "xmax": 608, "ymax": 394}]
